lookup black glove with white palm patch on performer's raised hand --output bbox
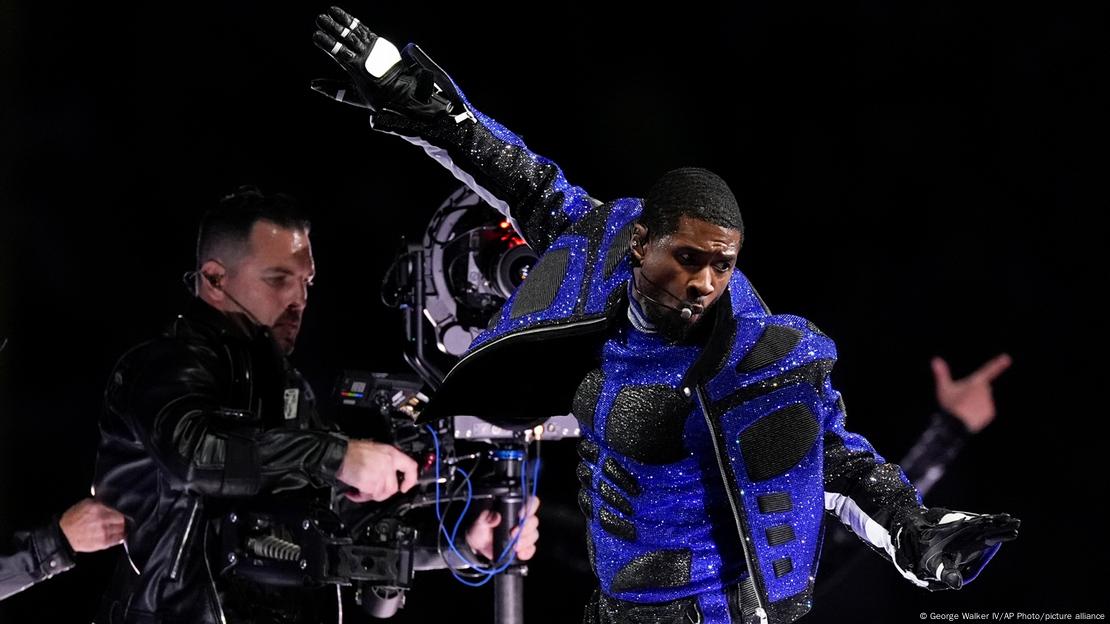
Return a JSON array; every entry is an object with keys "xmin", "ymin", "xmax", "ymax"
[{"xmin": 312, "ymin": 7, "xmax": 471, "ymax": 121}]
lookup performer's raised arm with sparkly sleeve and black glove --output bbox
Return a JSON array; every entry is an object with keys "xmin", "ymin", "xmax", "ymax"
[{"xmin": 312, "ymin": 7, "xmax": 601, "ymax": 253}]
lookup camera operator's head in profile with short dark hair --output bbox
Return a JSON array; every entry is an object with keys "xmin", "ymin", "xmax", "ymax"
[{"xmin": 196, "ymin": 187, "xmax": 316, "ymax": 353}]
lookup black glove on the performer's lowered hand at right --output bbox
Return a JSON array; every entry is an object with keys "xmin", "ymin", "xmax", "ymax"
[{"xmin": 894, "ymin": 507, "xmax": 1021, "ymax": 590}]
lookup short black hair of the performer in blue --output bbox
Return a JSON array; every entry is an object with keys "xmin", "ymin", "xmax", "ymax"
[{"xmin": 638, "ymin": 167, "xmax": 744, "ymax": 236}]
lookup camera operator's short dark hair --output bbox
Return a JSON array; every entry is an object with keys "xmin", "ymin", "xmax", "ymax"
[{"xmin": 196, "ymin": 185, "xmax": 311, "ymax": 264}]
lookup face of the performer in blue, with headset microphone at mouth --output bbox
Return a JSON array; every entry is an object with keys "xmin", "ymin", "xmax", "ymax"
[{"xmin": 633, "ymin": 217, "xmax": 740, "ymax": 338}]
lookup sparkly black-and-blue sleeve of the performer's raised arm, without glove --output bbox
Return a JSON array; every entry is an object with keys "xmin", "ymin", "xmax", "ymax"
[{"xmin": 372, "ymin": 97, "xmax": 601, "ymax": 253}]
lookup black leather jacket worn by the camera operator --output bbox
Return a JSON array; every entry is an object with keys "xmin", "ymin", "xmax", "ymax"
[{"xmin": 95, "ymin": 299, "xmax": 346, "ymax": 624}]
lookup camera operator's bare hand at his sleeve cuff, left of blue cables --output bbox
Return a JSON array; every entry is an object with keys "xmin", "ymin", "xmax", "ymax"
[{"xmin": 335, "ymin": 440, "xmax": 416, "ymax": 503}]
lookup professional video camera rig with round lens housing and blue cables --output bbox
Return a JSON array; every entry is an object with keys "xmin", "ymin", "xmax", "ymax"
[{"xmin": 221, "ymin": 189, "xmax": 579, "ymax": 623}]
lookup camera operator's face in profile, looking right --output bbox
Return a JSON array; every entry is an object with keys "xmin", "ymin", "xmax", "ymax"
[{"xmin": 206, "ymin": 221, "xmax": 316, "ymax": 353}]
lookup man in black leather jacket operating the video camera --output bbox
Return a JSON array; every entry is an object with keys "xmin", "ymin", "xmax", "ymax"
[{"xmin": 97, "ymin": 188, "xmax": 538, "ymax": 624}]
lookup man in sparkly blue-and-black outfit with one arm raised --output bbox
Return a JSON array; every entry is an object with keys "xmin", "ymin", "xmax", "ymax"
[{"xmin": 313, "ymin": 8, "xmax": 1018, "ymax": 624}]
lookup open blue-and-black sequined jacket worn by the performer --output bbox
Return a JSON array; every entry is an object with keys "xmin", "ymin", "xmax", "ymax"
[{"xmin": 372, "ymin": 73, "xmax": 1003, "ymax": 623}]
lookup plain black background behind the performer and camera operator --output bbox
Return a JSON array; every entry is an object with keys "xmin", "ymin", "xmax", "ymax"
[{"xmin": 0, "ymin": 0, "xmax": 1107, "ymax": 623}]
